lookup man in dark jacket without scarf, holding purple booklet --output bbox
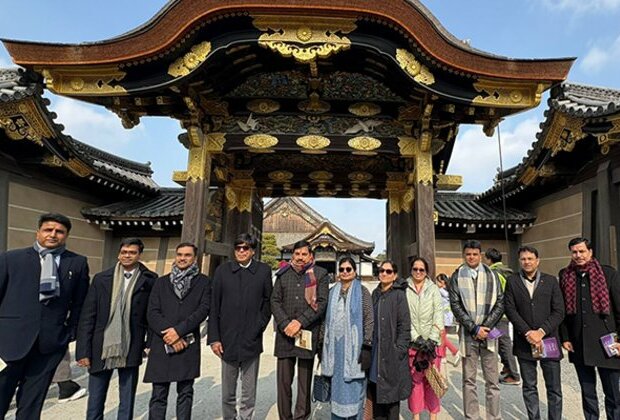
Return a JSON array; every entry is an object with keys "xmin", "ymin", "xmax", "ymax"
[{"xmin": 504, "ymin": 246, "xmax": 564, "ymax": 420}]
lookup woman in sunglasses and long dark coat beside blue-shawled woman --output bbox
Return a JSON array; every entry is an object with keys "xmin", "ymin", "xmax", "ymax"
[{"xmin": 368, "ymin": 261, "xmax": 411, "ymax": 420}]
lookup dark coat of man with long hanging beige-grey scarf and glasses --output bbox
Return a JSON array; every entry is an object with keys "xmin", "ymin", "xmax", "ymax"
[{"xmin": 75, "ymin": 264, "xmax": 157, "ymax": 373}]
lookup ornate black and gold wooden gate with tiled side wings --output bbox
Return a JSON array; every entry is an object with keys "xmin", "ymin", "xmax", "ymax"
[{"xmin": 0, "ymin": 0, "xmax": 620, "ymax": 272}]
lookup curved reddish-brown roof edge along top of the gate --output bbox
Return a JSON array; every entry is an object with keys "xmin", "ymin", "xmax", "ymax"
[{"xmin": 3, "ymin": 0, "xmax": 574, "ymax": 82}]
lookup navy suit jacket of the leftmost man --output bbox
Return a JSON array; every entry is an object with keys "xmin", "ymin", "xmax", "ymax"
[{"xmin": 0, "ymin": 248, "xmax": 89, "ymax": 362}]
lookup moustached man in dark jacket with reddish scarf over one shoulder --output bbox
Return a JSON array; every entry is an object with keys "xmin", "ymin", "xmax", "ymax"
[{"xmin": 271, "ymin": 241, "xmax": 329, "ymax": 420}]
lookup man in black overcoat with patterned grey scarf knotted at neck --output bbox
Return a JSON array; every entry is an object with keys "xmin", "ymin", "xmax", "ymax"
[{"xmin": 144, "ymin": 242, "xmax": 211, "ymax": 420}]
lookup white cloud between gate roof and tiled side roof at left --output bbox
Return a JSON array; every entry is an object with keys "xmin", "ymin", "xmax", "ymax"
[{"xmin": 49, "ymin": 95, "xmax": 144, "ymax": 156}]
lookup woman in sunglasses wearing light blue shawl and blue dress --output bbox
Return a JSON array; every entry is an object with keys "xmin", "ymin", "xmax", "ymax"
[{"xmin": 321, "ymin": 257, "xmax": 373, "ymax": 419}]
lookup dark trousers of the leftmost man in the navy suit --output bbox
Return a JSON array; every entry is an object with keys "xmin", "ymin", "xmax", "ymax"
[{"xmin": 0, "ymin": 340, "xmax": 67, "ymax": 420}]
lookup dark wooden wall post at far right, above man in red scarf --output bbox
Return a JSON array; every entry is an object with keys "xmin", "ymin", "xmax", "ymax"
[{"xmin": 591, "ymin": 161, "xmax": 617, "ymax": 264}]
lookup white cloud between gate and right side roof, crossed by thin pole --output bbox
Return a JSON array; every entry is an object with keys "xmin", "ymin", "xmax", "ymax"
[{"xmin": 446, "ymin": 117, "xmax": 539, "ymax": 192}]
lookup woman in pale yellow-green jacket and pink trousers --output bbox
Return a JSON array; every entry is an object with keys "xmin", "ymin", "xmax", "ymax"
[{"xmin": 406, "ymin": 257, "xmax": 445, "ymax": 420}]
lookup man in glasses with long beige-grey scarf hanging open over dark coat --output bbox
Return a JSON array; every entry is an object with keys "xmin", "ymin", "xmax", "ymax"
[{"xmin": 75, "ymin": 238, "xmax": 157, "ymax": 420}]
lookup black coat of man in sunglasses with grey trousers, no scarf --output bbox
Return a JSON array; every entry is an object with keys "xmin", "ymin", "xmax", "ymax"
[{"xmin": 207, "ymin": 260, "xmax": 273, "ymax": 363}]
